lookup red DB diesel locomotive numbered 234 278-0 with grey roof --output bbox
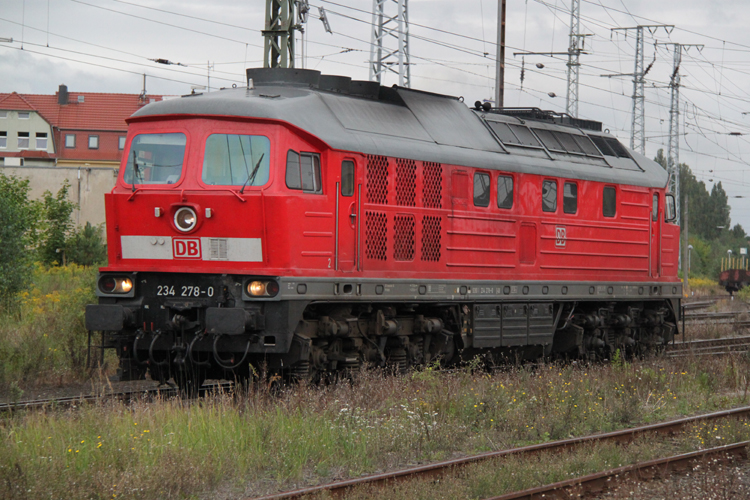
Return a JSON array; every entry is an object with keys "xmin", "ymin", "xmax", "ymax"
[{"xmin": 86, "ymin": 69, "xmax": 682, "ymax": 388}]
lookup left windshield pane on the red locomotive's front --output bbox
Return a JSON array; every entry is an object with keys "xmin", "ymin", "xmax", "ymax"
[{"xmin": 123, "ymin": 133, "xmax": 186, "ymax": 186}]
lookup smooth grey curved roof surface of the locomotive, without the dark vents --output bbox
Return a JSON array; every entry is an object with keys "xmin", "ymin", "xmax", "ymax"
[{"xmin": 133, "ymin": 84, "xmax": 667, "ymax": 187}]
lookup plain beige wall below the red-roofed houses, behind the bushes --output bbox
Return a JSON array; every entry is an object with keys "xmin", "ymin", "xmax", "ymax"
[{"xmin": 0, "ymin": 166, "xmax": 119, "ymax": 226}]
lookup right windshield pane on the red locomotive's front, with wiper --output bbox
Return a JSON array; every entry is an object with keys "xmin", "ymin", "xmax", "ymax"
[{"xmin": 202, "ymin": 134, "xmax": 271, "ymax": 186}]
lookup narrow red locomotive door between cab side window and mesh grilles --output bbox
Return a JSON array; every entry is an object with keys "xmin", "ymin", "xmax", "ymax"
[{"xmin": 336, "ymin": 160, "xmax": 361, "ymax": 272}]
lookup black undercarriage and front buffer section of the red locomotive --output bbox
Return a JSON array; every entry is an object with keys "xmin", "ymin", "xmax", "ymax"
[{"xmin": 87, "ymin": 274, "xmax": 679, "ymax": 390}]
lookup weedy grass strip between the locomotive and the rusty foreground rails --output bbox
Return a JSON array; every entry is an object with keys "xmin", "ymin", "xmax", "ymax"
[{"xmin": 0, "ymin": 357, "xmax": 750, "ymax": 498}]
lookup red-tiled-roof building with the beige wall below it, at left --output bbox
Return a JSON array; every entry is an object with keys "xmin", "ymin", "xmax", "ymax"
[{"xmin": 0, "ymin": 85, "xmax": 163, "ymax": 224}]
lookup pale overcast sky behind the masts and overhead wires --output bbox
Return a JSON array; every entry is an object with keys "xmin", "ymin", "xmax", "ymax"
[{"xmin": 0, "ymin": 0, "xmax": 750, "ymax": 231}]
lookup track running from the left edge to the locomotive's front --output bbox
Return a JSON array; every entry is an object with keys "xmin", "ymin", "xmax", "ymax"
[{"xmin": 0, "ymin": 382, "xmax": 233, "ymax": 413}]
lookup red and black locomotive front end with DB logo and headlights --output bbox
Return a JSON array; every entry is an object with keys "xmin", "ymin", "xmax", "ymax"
[{"xmin": 86, "ymin": 108, "xmax": 306, "ymax": 387}]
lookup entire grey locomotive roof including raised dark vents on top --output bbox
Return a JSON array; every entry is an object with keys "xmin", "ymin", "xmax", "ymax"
[{"xmin": 132, "ymin": 68, "xmax": 667, "ymax": 188}]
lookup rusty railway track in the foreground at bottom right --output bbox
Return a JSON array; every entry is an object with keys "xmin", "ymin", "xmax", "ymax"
[{"xmin": 250, "ymin": 406, "xmax": 750, "ymax": 500}]
